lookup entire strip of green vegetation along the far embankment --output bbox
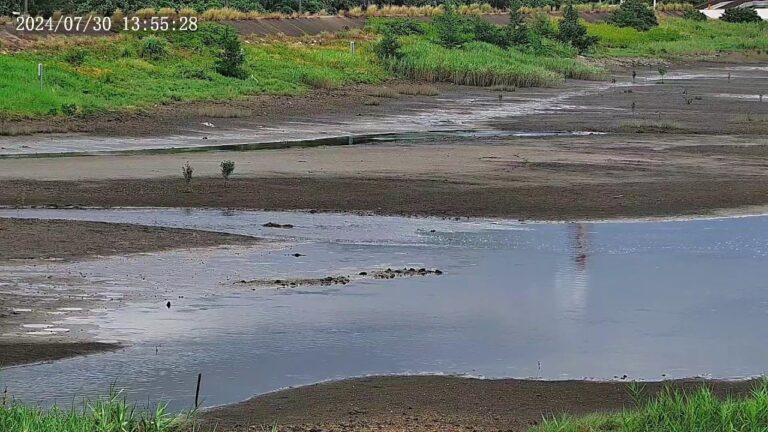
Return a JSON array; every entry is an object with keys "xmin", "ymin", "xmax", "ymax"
[{"xmin": 0, "ymin": 18, "xmax": 768, "ymax": 117}]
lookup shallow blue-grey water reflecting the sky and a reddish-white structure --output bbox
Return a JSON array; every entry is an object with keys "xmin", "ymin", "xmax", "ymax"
[{"xmin": 0, "ymin": 209, "xmax": 768, "ymax": 408}]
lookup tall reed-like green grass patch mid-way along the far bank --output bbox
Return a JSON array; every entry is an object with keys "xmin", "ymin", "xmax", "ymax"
[{"xmin": 391, "ymin": 37, "xmax": 603, "ymax": 87}]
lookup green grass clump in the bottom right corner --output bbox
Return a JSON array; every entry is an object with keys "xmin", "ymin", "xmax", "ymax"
[{"xmin": 534, "ymin": 381, "xmax": 768, "ymax": 432}]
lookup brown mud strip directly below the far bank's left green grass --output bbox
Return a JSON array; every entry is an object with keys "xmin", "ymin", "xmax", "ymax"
[{"xmin": 0, "ymin": 81, "xmax": 432, "ymax": 138}]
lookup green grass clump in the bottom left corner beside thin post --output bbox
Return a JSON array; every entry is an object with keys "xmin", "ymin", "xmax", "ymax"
[{"xmin": 0, "ymin": 391, "xmax": 194, "ymax": 432}]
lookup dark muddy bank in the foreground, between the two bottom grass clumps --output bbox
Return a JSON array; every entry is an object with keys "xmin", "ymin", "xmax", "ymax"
[{"xmin": 202, "ymin": 376, "xmax": 754, "ymax": 432}]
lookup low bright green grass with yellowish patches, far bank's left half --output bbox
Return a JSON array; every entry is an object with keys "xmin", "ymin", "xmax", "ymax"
[{"xmin": 0, "ymin": 29, "xmax": 388, "ymax": 116}]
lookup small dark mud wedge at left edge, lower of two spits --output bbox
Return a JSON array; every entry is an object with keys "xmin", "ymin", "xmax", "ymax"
[{"xmin": 0, "ymin": 342, "xmax": 120, "ymax": 368}]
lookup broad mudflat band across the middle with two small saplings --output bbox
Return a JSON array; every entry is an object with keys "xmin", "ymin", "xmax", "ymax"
[{"xmin": 0, "ymin": 134, "xmax": 768, "ymax": 220}]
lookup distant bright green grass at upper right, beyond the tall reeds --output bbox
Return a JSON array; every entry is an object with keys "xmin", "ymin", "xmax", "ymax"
[{"xmin": 587, "ymin": 18, "xmax": 768, "ymax": 58}]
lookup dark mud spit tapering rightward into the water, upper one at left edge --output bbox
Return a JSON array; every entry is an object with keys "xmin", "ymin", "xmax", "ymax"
[{"xmin": 0, "ymin": 218, "xmax": 258, "ymax": 261}]
